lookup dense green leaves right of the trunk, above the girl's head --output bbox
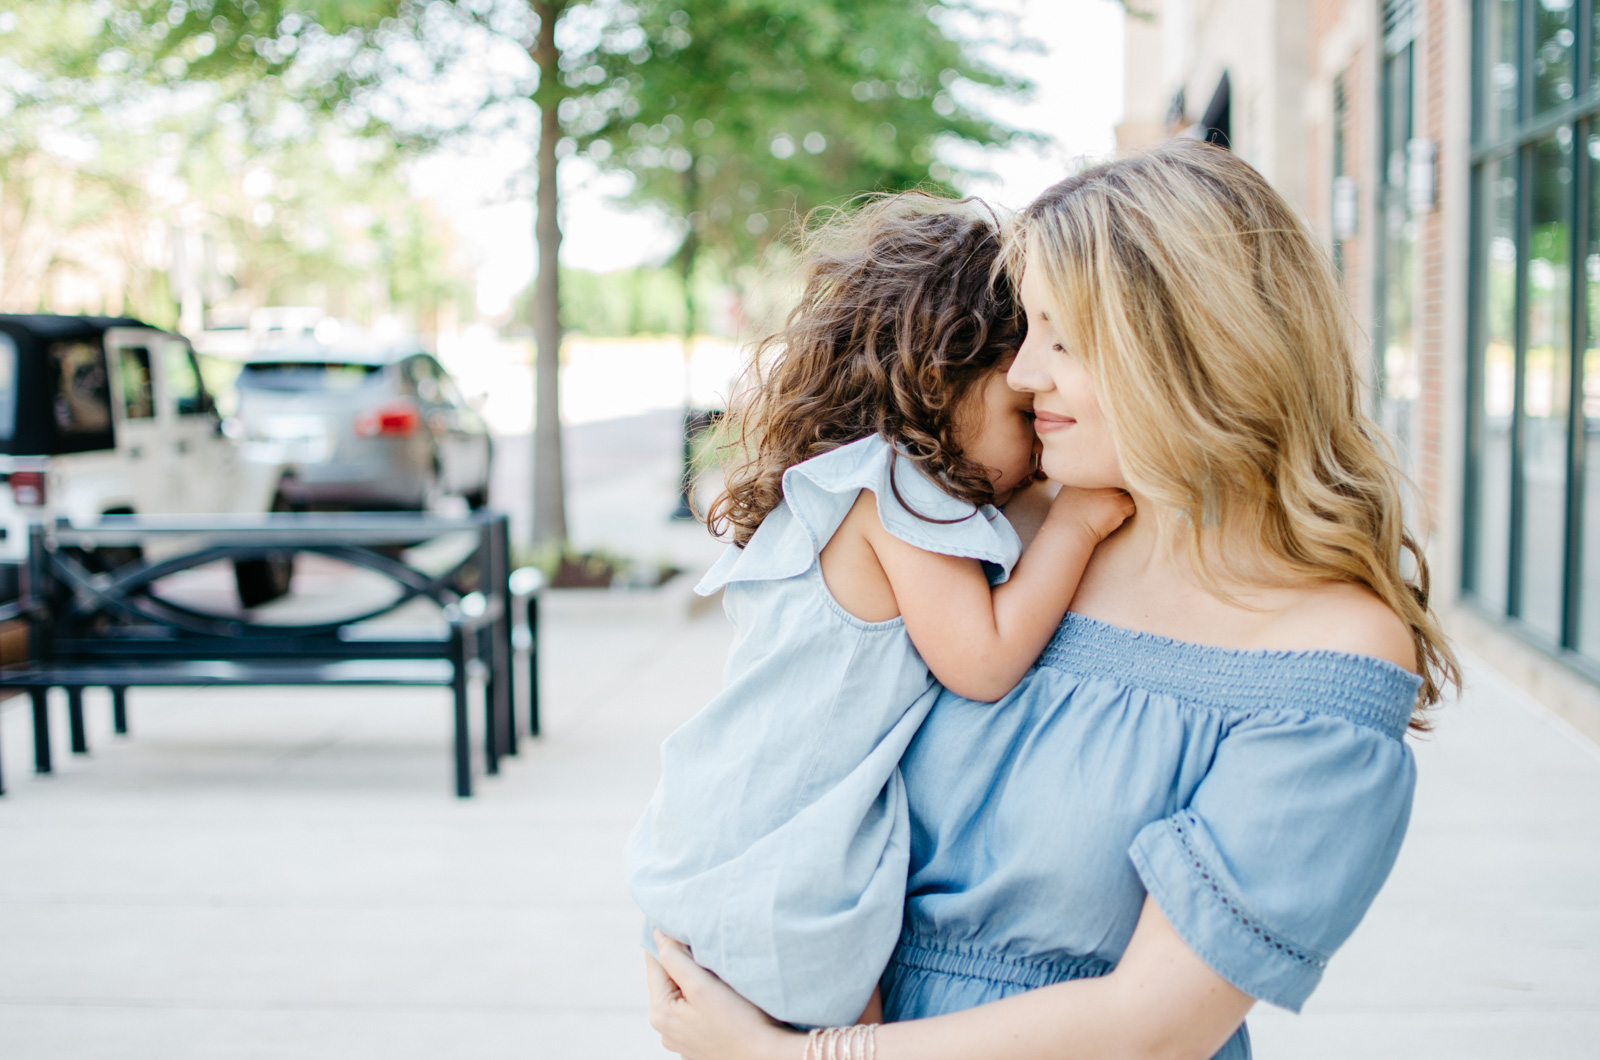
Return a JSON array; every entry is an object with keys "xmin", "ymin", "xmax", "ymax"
[{"xmin": 585, "ymin": 0, "xmax": 1022, "ymax": 273}]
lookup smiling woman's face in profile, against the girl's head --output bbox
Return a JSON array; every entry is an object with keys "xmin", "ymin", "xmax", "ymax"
[{"xmin": 1006, "ymin": 269, "xmax": 1128, "ymax": 488}]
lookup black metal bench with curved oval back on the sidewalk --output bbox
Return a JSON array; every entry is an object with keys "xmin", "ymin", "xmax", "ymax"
[{"xmin": 0, "ymin": 512, "xmax": 539, "ymax": 797}]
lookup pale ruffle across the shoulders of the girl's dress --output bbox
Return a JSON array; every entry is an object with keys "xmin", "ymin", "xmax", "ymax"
[{"xmin": 694, "ymin": 434, "xmax": 1022, "ymax": 596}]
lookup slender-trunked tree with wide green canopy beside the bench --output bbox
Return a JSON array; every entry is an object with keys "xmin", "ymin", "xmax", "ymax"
[{"xmin": 51, "ymin": 0, "xmax": 1013, "ymax": 543}]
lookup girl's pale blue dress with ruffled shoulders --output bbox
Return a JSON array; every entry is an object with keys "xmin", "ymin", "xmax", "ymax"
[{"xmin": 627, "ymin": 437, "xmax": 1021, "ymax": 1026}]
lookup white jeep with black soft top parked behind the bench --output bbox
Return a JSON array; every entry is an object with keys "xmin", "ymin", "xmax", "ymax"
[{"xmin": 0, "ymin": 314, "xmax": 293, "ymax": 607}]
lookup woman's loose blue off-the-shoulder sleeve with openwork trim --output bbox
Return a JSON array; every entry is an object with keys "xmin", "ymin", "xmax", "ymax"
[{"xmin": 1130, "ymin": 660, "xmax": 1418, "ymax": 1012}]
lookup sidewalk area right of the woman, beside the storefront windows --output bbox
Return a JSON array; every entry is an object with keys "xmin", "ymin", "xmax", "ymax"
[{"xmin": 1251, "ymin": 656, "xmax": 1600, "ymax": 1060}]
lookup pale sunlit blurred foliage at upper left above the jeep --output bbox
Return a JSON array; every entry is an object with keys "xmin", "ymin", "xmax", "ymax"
[{"xmin": 0, "ymin": 0, "xmax": 466, "ymax": 325}]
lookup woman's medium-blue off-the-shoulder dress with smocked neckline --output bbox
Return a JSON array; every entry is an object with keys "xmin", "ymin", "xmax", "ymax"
[{"xmin": 883, "ymin": 615, "xmax": 1421, "ymax": 1060}]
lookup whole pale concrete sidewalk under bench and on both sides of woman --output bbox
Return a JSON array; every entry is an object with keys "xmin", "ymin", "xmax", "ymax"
[{"xmin": 0, "ymin": 413, "xmax": 1600, "ymax": 1060}]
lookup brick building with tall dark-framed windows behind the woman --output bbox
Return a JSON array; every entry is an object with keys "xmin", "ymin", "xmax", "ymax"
[{"xmin": 1117, "ymin": 0, "xmax": 1600, "ymax": 738}]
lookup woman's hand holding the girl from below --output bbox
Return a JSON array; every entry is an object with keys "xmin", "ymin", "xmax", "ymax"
[{"xmin": 645, "ymin": 932, "xmax": 805, "ymax": 1060}]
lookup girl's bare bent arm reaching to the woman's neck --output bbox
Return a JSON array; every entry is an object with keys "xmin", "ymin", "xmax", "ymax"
[{"xmin": 862, "ymin": 487, "xmax": 1133, "ymax": 701}]
